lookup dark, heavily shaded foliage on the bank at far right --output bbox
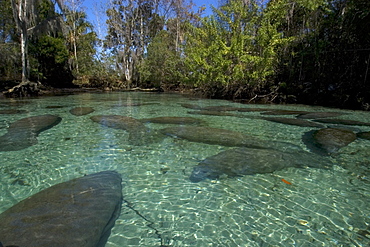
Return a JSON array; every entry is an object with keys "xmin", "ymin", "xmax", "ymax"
[{"xmin": 278, "ymin": 0, "xmax": 370, "ymax": 109}]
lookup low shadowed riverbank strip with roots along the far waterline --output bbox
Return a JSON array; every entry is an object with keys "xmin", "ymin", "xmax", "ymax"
[{"xmin": 0, "ymin": 78, "xmax": 370, "ymax": 111}]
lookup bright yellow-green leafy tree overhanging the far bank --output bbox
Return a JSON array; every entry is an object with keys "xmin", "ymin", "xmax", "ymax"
[{"xmin": 185, "ymin": 0, "xmax": 291, "ymax": 97}]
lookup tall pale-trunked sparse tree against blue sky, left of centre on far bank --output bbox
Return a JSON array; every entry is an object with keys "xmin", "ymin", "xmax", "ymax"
[{"xmin": 105, "ymin": 0, "xmax": 163, "ymax": 84}]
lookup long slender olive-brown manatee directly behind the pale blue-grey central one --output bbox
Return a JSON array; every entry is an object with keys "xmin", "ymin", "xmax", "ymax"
[{"xmin": 160, "ymin": 126, "xmax": 296, "ymax": 149}]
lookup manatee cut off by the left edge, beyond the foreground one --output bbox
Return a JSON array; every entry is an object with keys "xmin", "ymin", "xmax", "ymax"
[{"xmin": 0, "ymin": 115, "xmax": 62, "ymax": 151}]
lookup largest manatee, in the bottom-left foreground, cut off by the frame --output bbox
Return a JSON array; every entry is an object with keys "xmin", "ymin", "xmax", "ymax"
[{"xmin": 0, "ymin": 171, "xmax": 122, "ymax": 247}]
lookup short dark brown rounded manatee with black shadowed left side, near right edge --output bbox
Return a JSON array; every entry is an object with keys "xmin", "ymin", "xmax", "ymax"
[{"xmin": 303, "ymin": 128, "xmax": 356, "ymax": 155}]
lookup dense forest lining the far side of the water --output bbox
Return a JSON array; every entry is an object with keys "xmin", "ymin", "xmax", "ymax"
[{"xmin": 0, "ymin": 0, "xmax": 370, "ymax": 110}]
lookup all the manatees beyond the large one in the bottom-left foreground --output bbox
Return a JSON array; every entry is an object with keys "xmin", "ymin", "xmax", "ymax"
[{"xmin": 0, "ymin": 104, "xmax": 370, "ymax": 181}]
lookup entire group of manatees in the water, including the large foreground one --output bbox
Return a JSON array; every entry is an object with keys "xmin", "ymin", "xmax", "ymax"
[{"xmin": 0, "ymin": 101, "xmax": 370, "ymax": 247}]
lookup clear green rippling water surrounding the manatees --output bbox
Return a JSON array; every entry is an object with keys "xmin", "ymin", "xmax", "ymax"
[{"xmin": 0, "ymin": 93, "xmax": 370, "ymax": 247}]
